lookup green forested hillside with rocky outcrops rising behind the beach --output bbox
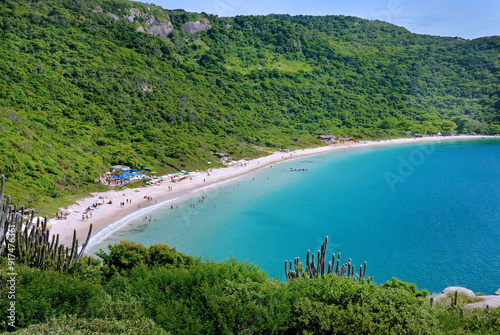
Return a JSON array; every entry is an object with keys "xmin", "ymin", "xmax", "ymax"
[{"xmin": 0, "ymin": 0, "xmax": 500, "ymax": 210}]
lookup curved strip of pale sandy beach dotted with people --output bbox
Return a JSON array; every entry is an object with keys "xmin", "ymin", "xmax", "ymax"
[{"xmin": 49, "ymin": 135, "xmax": 493, "ymax": 251}]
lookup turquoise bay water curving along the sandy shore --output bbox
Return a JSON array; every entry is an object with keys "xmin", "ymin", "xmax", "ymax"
[{"xmin": 91, "ymin": 139, "xmax": 500, "ymax": 294}]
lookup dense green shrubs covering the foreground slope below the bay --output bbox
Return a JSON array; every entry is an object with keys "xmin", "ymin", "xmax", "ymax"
[{"xmin": 0, "ymin": 242, "xmax": 500, "ymax": 335}]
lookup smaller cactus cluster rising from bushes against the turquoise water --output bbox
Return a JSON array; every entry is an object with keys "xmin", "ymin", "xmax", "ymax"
[{"xmin": 285, "ymin": 236, "xmax": 366, "ymax": 280}]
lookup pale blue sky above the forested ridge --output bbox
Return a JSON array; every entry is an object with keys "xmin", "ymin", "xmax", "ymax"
[{"xmin": 146, "ymin": 0, "xmax": 500, "ymax": 39}]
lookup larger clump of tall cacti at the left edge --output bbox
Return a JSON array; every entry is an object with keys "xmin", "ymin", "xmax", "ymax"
[{"xmin": 0, "ymin": 176, "xmax": 92, "ymax": 271}]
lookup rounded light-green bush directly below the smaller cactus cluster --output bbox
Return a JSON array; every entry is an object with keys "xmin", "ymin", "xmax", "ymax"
[{"xmin": 289, "ymin": 275, "xmax": 437, "ymax": 334}]
